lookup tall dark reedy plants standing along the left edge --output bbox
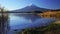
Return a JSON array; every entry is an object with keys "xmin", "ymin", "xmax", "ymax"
[{"xmin": 0, "ymin": 5, "xmax": 9, "ymax": 34}]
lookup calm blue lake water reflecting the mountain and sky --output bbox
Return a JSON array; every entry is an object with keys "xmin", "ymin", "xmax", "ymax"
[{"xmin": 9, "ymin": 13, "xmax": 56, "ymax": 29}]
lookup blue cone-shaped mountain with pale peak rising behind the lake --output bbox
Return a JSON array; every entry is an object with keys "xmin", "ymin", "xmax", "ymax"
[{"xmin": 11, "ymin": 4, "xmax": 49, "ymax": 12}]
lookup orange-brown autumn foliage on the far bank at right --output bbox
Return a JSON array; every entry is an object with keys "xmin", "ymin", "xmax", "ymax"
[{"xmin": 38, "ymin": 11, "xmax": 60, "ymax": 18}]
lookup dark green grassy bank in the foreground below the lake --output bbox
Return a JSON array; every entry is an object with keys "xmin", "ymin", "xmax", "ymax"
[{"xmin": 22, "ymin": 22, "xmax": 60, "ymax": 34}]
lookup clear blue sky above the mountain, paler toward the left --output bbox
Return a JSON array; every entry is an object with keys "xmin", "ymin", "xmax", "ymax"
[{"xmin": 0, "ymin": 0, "xmax": 60, "ymax": 10}]
